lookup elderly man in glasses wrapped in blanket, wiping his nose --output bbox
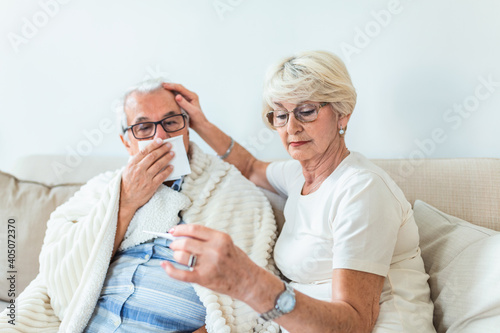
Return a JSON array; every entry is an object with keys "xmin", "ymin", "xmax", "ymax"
[{"xmin": 0, "ymin": 80, "xmax": 277, "ymax": 332}]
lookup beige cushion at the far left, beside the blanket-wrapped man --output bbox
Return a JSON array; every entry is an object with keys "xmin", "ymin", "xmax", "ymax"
[{"xmin": 0, "ymin": 171, "xmax": 82, "ymax": 301}]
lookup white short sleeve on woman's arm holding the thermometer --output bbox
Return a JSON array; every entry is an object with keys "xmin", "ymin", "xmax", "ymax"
[{"xmin": 332, "ymin": 171, "xmax": 403, "ymax": 276}]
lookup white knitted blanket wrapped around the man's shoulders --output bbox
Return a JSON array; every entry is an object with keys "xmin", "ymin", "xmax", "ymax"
[{"xmin": 0, "ymin": 143, "xmax": 279, "ymax": 333}]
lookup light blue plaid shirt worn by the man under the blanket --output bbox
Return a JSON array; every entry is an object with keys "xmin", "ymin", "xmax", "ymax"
[{"xmin": 84, "ymin": 179, "xmax": 206, "ymax": 333}]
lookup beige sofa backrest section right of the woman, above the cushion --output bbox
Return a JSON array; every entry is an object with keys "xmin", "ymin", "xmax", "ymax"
[{"xmin": 372, "ymin": 158, "xmax": 500, "ymax": 231}]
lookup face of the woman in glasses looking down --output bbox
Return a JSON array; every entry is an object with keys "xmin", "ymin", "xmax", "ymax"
[{"xmin": 277, "ymin": 102, "xmax": 345, "ymax": 161}]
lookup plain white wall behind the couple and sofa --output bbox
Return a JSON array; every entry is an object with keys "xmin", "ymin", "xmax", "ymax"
[{"xmin": 0, "ymin": 0, "xmax": 500, "ymax": 174}]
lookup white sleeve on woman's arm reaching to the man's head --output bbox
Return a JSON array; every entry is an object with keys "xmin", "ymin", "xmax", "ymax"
[{"xmin": 266, "ymin": 160, "xmax": 302, "ymax": 197}]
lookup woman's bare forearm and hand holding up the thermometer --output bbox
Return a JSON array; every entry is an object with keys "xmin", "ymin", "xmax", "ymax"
[{"xmin": 164, "ymin": 225, "xmax": 384, "ymax": 332}]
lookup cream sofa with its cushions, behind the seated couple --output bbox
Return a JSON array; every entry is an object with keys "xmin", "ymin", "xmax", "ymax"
[{"xmin": 0, "ymin": 156, "xmax": 500, "ymax": 333}]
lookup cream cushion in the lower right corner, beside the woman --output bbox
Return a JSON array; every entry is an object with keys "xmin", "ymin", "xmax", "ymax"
[{"xmin": 413, "ymin": 200, "xmax": 500, "ymax": 333}]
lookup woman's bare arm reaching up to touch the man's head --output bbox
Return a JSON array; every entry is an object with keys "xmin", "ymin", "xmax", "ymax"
[{"xmin": 163, "ymin": 83, "xmax": 276, "ymax": 192}]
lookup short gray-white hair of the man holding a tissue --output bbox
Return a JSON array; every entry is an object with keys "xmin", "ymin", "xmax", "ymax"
[{"xmin": 115, "ymin": 77, "xmax": 189, "ymax": 141}]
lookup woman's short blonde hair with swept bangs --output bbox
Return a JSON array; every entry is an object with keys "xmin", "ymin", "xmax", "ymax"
[{"xmin": 262, "ymin": 51, "xmax": 357, "ymax": 123}]
